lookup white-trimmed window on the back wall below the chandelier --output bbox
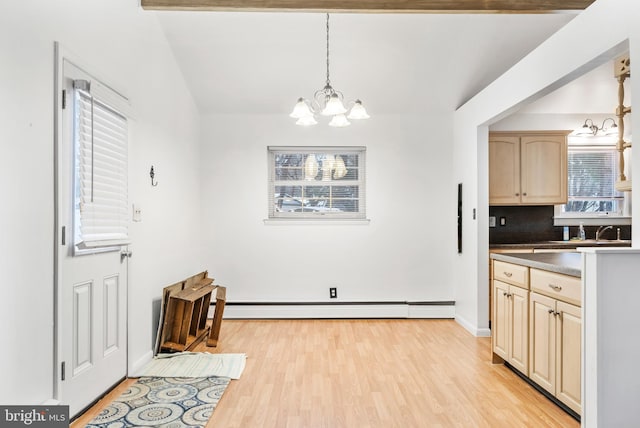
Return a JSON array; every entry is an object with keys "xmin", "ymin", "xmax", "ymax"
[{"xmin": 268, "ymin": 147, "xmax": 366, "ymax": 219}]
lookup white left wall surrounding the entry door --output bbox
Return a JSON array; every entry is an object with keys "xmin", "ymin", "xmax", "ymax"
[{"xmin": 0, "ymin": 0, "xmax": 202, "ymax": 404}]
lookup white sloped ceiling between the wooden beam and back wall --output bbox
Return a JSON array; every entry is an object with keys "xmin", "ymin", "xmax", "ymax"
[{"xmin": 152, "ymin": 12, "xmax": 584, "ymax": 115}]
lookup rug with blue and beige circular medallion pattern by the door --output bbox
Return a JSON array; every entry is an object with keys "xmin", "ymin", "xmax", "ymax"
[{"xmin": 87, "ymin": 376, "xmax": 230, "ymax": 428}]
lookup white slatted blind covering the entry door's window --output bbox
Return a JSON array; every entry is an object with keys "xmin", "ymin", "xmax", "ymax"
[{"xmin": 74, "ymin": 85, "xmax": 128, "ymax": 249}]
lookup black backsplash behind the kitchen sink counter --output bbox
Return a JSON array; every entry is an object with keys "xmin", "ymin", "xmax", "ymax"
[{"xmin": 489, "ymin": 205, "xmax": 631, "ymax": 244}]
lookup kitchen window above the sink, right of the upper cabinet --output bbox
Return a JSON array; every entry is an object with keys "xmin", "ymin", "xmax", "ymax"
[{"xmin": 556, "ymin": 144, "xmax": 624, "ymax": 218}]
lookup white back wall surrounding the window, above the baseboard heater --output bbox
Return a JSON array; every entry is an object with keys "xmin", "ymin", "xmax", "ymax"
[{"xmin": 202, "ymin": 115, "xmax": 456, "ymax": 308}]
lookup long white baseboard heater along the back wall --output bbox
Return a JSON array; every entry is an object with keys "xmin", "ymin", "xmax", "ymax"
[{"xmin": 214, "ymin": 301, "xmax": 455, "ymax": 319}]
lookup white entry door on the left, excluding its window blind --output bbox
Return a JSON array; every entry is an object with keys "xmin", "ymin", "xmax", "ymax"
[{"xmin": 55, "ymin": 52, "xmax": 130, "ymax": 416}]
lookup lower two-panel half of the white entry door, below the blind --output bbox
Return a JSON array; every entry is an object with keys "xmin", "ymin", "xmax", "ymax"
[{"xmin": 59, "ymin": 246, "xmax": 127, "ymax": 414}]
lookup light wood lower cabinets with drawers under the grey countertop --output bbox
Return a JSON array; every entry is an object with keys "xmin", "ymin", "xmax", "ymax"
[{"xmin": 491, "ymin": 260, "xmax": 582, "ymax": 415}]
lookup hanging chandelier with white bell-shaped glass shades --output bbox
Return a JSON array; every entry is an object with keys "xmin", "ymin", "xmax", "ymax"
[{"xmin": 289, "ymin": 13, "xmax": 369, "ymax": 127}]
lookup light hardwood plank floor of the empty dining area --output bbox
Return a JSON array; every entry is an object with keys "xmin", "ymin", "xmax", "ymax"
[{"xmin": 72, "ymin": 320, "xmax": 580, "ymax": 428}]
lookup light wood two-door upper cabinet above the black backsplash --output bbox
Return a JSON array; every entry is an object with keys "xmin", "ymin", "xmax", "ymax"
[{"xmin": 489, "ymin": 131, "xmax": 570, "ymax": 205}]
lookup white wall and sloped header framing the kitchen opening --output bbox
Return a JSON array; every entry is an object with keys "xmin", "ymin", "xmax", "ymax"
[{"xmin": 453, "ymin": 0, "xmax": 640, "ymax": 334}]
